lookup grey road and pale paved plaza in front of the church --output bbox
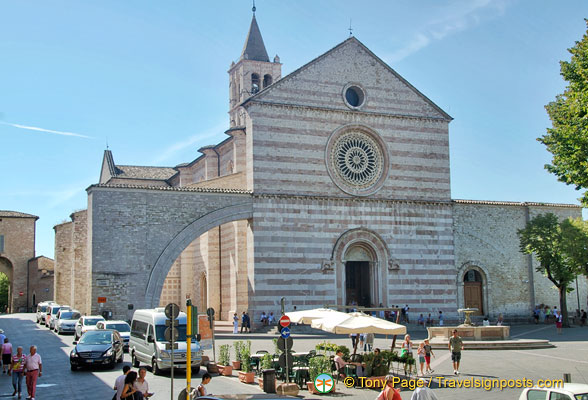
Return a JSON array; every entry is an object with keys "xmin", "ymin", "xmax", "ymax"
[{"xmin": 0, "ymin": 314, "xmax": 588, "ymax": 400}]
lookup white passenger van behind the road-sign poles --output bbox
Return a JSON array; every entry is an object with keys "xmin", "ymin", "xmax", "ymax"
[{"xmin": 129, "ymin": 308, "xmax": 202, "ymax": 375}]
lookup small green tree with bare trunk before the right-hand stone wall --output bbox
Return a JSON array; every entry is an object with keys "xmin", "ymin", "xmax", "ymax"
[{"xmin": 517, "ymin": 213, "xmax": 579, "ymax": 327}]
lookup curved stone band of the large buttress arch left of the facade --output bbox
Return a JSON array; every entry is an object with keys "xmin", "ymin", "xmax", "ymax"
[{"xmin": 145, "ymin": 203, "xmax": 253, "ymax": 308}]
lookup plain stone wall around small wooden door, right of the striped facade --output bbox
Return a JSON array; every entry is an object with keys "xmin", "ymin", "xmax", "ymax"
[{"xmin": 453, "ymin": 202, "xmax": 587, "ymax": 317}]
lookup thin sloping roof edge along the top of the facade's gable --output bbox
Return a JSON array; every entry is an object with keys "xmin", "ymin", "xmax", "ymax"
[{"xmin": 241, "ymin": 36, "xmax": 453, "ymax": 121}]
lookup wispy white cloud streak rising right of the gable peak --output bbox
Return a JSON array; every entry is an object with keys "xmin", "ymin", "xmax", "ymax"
[{"xmin": 385, "ymin": 0, "xmax": 508, "ymax": 63}]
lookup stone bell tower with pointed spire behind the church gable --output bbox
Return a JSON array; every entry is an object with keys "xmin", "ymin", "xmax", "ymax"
[{"xmin": 229, "ymin": 3, "xmax": 282, "ymax": 127}]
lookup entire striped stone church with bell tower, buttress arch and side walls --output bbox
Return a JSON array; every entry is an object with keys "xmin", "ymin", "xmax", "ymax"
[{"xmin": 55, "ymin": 16, "xmax": 588, "ymax": 321}]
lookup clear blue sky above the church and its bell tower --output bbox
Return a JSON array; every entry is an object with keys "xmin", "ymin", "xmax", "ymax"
[{"xmin": 0, "ymin": 0, "xmax": 588, "ymax": 257}]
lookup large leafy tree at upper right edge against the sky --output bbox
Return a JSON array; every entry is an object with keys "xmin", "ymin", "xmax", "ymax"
[{"xmin": 537, "ymin": 20, "xmax": 588, "ymax": 205}]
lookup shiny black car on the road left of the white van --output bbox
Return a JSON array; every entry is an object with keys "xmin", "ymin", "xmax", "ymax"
[{"xmin": 69, "ymin": 330, "xmax": 124, "ymax": 371}]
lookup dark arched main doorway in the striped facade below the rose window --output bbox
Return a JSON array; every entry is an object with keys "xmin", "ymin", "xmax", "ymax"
[{"xmin": 344, "ymin": 244, "xmax": 375, "ymax": 307}]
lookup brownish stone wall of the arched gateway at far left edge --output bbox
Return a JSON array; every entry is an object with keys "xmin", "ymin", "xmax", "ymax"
[{"xmin": 0, "ymin": 216, "xmax": 37, "ymax": 312}]
